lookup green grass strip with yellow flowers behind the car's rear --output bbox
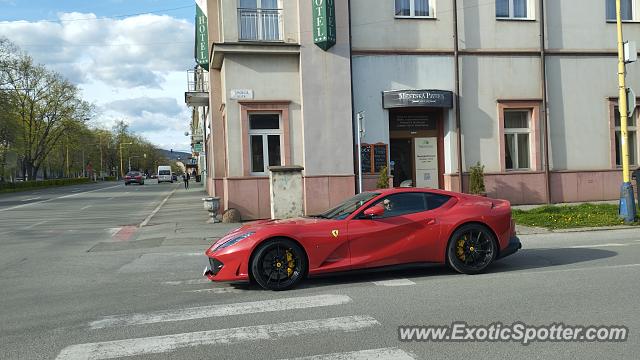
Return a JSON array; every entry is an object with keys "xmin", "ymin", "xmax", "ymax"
[{"xmin": 513, "ymin": 204, "xmax": 638, "ymax": 229}]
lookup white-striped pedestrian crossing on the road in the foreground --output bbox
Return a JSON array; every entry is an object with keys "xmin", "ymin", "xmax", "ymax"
[{"xmin": 56, "ymin": 294, "xmax": 414, "ymax": 360}]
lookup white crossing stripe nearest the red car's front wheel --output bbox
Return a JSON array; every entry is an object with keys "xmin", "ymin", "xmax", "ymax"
[{"xmin": 89, "ymin": 295, "xmax": 351, "ymax": 329}]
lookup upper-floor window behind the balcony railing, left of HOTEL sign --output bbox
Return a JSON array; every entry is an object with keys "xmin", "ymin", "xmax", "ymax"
[{"xmin": 238, "ymin": 0, "xmax": 282, "ymax": 41}]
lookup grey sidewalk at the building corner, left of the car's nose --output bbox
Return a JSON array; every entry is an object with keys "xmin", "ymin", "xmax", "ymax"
[{"xmin": 136, "ymin": 182, "xmax": 240, "ymax": 246}]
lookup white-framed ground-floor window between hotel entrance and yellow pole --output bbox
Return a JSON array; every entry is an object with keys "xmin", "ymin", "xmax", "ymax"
[{"xmin": 504, "ymin": 109, "xmax": 532, "ymax": 170}]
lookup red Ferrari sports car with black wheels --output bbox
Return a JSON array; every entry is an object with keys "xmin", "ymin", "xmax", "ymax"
[{"xmin": 204, "ymin": 188, "xmax": 521, "ymax": 290}]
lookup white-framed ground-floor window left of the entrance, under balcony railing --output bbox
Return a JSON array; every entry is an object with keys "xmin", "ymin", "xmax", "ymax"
[{"xmin": 249, "ymin": 113, "xmax": 283, "ymax": 175}]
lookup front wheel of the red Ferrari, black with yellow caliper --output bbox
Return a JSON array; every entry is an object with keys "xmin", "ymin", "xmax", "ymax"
[{"xmin": 251, "ymin": 239, "xmax": 307, "ymax": 291}]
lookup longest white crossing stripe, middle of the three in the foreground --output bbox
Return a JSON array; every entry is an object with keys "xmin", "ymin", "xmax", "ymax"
[{"xmin": 56, "ymin": 315, "xmax": 380, "ymax": 360}]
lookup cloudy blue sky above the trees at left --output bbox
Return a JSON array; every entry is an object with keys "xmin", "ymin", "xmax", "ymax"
[{"xmin": 0, "ymin": 0, "xmax": 195, "ymax": 150}]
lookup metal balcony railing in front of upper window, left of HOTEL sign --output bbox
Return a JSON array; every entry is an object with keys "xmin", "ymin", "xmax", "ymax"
[{"xmin": 238, "ymin": 8, "xmax": 282, "ymax": 41}]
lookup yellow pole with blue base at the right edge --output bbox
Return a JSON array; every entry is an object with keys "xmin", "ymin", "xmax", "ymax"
[{"xmin": 616, "ymin": 0, "xmax": 636, "ymax": 222}]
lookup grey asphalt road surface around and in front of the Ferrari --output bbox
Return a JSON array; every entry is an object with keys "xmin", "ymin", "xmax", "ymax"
[{"xmin": 0, "ymin": 183, "xmax": 640, "ymax": 359}]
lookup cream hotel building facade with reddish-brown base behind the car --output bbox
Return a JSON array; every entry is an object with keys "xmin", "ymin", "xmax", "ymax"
[{"xmin": 189, "ymin": 0, "xmax": 640, "ymax": 219}]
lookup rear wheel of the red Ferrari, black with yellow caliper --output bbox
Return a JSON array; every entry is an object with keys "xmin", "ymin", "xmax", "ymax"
[{"xmin": 447, "ymin": 224, "xmax": 498, "ymax": 275}]
